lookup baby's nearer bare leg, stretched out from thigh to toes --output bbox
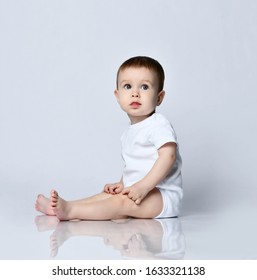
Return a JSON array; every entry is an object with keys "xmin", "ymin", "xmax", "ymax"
[{"xmin": 51, "ymin": 188, "xmax": 163, "ymax": 220}]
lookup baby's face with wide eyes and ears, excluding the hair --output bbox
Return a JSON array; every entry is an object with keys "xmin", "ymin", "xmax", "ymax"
[{"xmin": 114, "ymin": 67, "xmax": 164, "ymax": 124}]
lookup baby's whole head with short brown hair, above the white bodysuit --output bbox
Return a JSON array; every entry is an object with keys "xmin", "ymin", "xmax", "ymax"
[{"xmin": 114, "ymin": 56, "xmax": 165, "ymax": 124}]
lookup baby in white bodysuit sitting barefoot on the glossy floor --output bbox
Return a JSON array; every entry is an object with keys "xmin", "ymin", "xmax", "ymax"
[{"xmin": 35, "ymin": 56, "xmax": 183, "ymax": 220}]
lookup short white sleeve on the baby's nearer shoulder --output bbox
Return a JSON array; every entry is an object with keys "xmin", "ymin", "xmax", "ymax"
[{"xmin": 150, "ymin": 120, "xmax": 177, "ymax": 150}]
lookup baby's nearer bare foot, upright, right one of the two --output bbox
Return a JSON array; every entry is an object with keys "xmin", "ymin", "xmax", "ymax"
[{"xmin": 50, "ymin": 190, "xmax": 72, "ymax": 221}]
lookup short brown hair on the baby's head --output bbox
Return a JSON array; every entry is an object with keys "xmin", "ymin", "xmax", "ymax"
[{"xmin": 116, "ymin": 56, "xmax": 165, "ymax": 92}]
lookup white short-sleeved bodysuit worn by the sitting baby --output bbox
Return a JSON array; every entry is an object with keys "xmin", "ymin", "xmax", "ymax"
[{"xmin": 121, "ymin": 113, "xmax": 183, "ymax": 218}]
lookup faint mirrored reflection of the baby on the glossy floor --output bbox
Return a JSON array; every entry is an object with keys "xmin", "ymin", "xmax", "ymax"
[{"xmin": 36, "ymin": 216, "xmax": 185, "ymax": 259}]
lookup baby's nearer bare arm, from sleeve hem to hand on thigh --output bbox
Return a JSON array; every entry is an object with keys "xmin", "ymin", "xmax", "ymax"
[{"xmin": 122, "ymin": 142, "xmax": 177, "ymax": 204}]
